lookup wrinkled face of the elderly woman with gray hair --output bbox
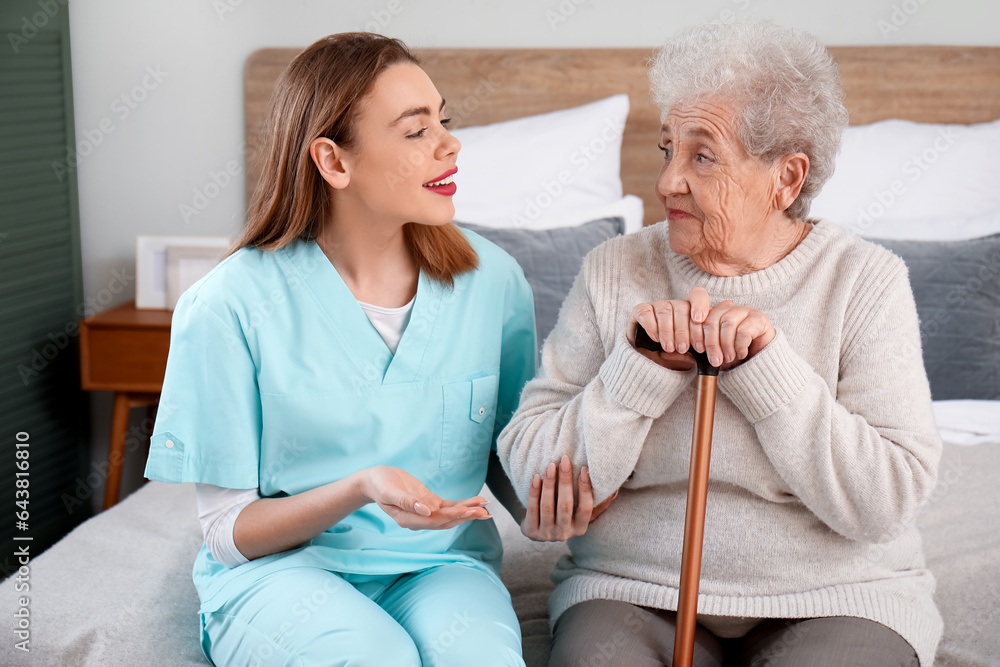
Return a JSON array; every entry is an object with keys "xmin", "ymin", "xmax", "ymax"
[{"xmin": 656, "ymin": 98, "xmax": 784, "ymax": 266}]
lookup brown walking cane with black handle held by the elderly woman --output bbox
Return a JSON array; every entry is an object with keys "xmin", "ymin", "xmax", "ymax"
[{"xmin": 635, "ymin": 326, "xmax": 719, "ymax": 667}]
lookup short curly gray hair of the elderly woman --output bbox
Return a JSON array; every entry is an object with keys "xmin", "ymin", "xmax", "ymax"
[{"xmin": 649, "ymin": 19, "xmax": 848, "ymax": 219}]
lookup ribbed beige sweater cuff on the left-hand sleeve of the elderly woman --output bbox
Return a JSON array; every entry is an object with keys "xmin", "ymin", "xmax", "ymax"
[{"xmin": 598, "ymin": 334, "xmax": 695, "ymax": 419}]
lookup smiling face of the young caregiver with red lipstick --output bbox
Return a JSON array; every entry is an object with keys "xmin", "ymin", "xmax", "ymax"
[{"xmin": 343, "ymin": 63, "xmax": 462, "ymax": 225}]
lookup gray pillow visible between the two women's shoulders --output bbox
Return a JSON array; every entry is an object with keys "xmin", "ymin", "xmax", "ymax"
[{"xmin": 456, "ymin": 217, "xmax": 625, "ymax": 348}]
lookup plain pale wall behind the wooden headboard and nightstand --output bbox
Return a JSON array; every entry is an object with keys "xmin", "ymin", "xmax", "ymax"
[{"xmin": 64, "ymin": 0, "xmax": 1000, "ymax": 506}]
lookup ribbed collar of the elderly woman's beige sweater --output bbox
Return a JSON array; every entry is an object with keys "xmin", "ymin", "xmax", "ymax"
[{"xmin": 663, "ymin": 220, "xmax": 843, "ymax": 296}]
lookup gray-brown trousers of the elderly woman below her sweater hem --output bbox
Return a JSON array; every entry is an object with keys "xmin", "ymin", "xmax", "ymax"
[{"xmin": 549, "ymin": 600, "xmax": 919, "ymax": 667}]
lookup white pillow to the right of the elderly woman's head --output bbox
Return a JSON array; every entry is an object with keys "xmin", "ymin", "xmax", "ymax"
[{"xmin": 810, "ymin": 120, "xmax": 1000, "ymax": 238}]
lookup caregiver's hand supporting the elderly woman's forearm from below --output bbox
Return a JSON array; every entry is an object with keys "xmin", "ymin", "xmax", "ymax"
[{"xmin": 521, "ymin": 456, "xmax": 618, "ymax": 542}]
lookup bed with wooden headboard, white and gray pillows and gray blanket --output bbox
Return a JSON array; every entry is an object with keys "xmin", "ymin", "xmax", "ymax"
[{"xmin": 0, "ymin": 47, "xmax": 1000, "ymax": 667}]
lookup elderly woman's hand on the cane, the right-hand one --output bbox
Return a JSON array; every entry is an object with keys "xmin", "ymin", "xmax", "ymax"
[{"xmin": 691, "ymin": 301, "xmax": 776, "ymax": 370}]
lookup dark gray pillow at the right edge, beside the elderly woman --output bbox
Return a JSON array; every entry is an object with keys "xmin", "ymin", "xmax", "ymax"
[{"xmin": 869, "ymin": 234, "xmax": 1000, "ymax": 401}]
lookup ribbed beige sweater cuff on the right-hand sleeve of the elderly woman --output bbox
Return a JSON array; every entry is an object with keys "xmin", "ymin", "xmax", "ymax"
[{"xmin": 719, "ymin": 330, "xmax": 815, "ymax": 424}]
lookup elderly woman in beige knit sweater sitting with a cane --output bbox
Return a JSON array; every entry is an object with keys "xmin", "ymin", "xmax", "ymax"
[{"xmin": 500, "ymin": 21, "xmax": 942, "ymax": 667}]
